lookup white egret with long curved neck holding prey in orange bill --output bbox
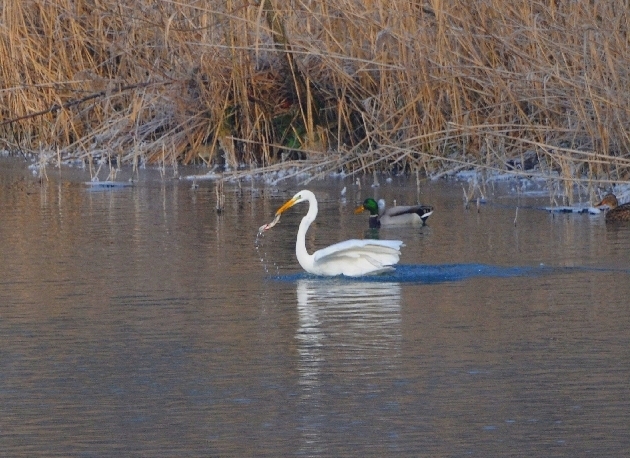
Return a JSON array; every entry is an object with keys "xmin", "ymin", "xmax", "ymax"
[{"xmin": 260, "ymin": 190, "xmax": 403, "ymax": 277}]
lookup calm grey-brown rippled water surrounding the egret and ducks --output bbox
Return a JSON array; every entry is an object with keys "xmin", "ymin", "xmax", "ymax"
[{"xmin": 0, "ymin": 160, "xmax": 630, "ymax": 457}]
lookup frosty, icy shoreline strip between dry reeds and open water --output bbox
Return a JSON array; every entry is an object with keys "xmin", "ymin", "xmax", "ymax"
[{"xmin": 0, "ymin": 151, "xmax": 630, "ymax": 212}]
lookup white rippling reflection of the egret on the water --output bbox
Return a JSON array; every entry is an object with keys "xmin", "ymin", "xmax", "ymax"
[{"xmin": 296, "ymin": 279, "xmax": 402, "ymax": 454}]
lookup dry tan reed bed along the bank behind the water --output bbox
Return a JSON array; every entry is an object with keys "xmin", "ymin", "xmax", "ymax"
[{"xmin": 0, "ymin": 0, "xmax": 630, "ymax": 192}]
